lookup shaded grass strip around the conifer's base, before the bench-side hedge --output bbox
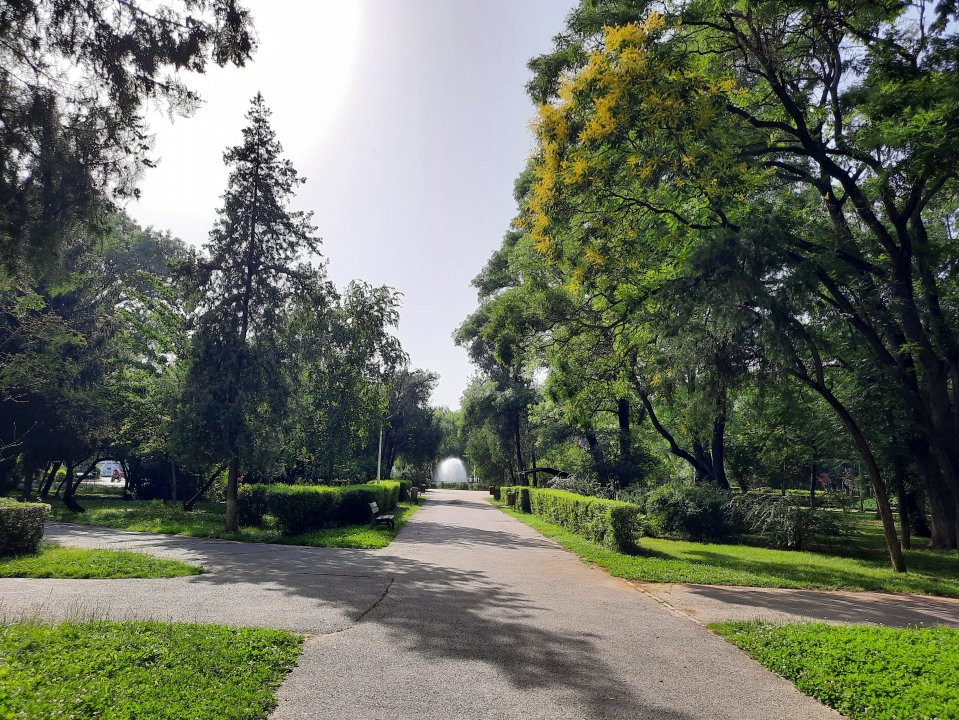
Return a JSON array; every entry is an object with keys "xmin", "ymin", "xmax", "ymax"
[{"xmin": 49, "ymin": 497, "xmax": 419, "ymax": 548}]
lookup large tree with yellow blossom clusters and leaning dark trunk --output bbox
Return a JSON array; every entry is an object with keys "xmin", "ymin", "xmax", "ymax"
[{"xmin": 510, "ymin": 2, "xmax": 959, "ymax": 570}]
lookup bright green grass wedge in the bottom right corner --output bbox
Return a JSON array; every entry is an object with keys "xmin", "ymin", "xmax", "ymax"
[{"xmin": 710, "ymin": 623, "xmax": 959, "ymax": 720}]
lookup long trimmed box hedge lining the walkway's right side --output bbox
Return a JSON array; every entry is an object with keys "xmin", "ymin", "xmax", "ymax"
[{"xmin": 500, "ymin": 486, "xmax": 642, "ymax": 553}]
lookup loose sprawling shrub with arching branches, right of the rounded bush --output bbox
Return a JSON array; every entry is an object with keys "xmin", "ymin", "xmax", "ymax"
[{"xmin": 729, "ymin": 495, "xmax": 842, "ymax": 550}]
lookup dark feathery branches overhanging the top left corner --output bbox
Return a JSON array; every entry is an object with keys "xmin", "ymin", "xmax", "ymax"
[{"xmin": 0, "ymin": 0, "xmax": 254, "ymax": 274}]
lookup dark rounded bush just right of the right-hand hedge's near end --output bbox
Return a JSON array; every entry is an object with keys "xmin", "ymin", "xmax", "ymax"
[{"xmin": 646, "ymin": 484, "xmax": 731, "ymax": 540}]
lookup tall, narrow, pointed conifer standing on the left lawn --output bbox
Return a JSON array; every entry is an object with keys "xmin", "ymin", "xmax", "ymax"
[{"xmin": 180, "ymin": 93, "xmax": 319, "ymax": 531}]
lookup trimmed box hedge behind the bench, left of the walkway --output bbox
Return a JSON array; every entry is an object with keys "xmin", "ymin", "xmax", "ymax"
[{"xmin": 244, "ymin": 480, "xmax": 400, "ymax": 535}]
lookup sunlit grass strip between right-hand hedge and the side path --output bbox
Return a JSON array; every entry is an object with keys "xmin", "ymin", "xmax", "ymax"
[{"xmin": 498, "ymin": 505, "xmax": 959, "ymax": 597}]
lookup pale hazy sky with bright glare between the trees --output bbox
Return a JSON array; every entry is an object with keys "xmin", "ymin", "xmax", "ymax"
[{"xmin": 128, "ymin": 0, "xmax": 573, "ymax": 407}]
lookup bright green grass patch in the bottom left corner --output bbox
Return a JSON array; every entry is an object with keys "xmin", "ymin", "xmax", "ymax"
[{"xmin": 0, "ymin": 622, "xmax": 303, "ymax": 720}]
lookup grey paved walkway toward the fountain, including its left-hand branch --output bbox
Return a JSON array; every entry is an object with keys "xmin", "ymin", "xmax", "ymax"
[{"xmin": 0, "ymin": 491, "xmax": 839, "ymax": 720}]
